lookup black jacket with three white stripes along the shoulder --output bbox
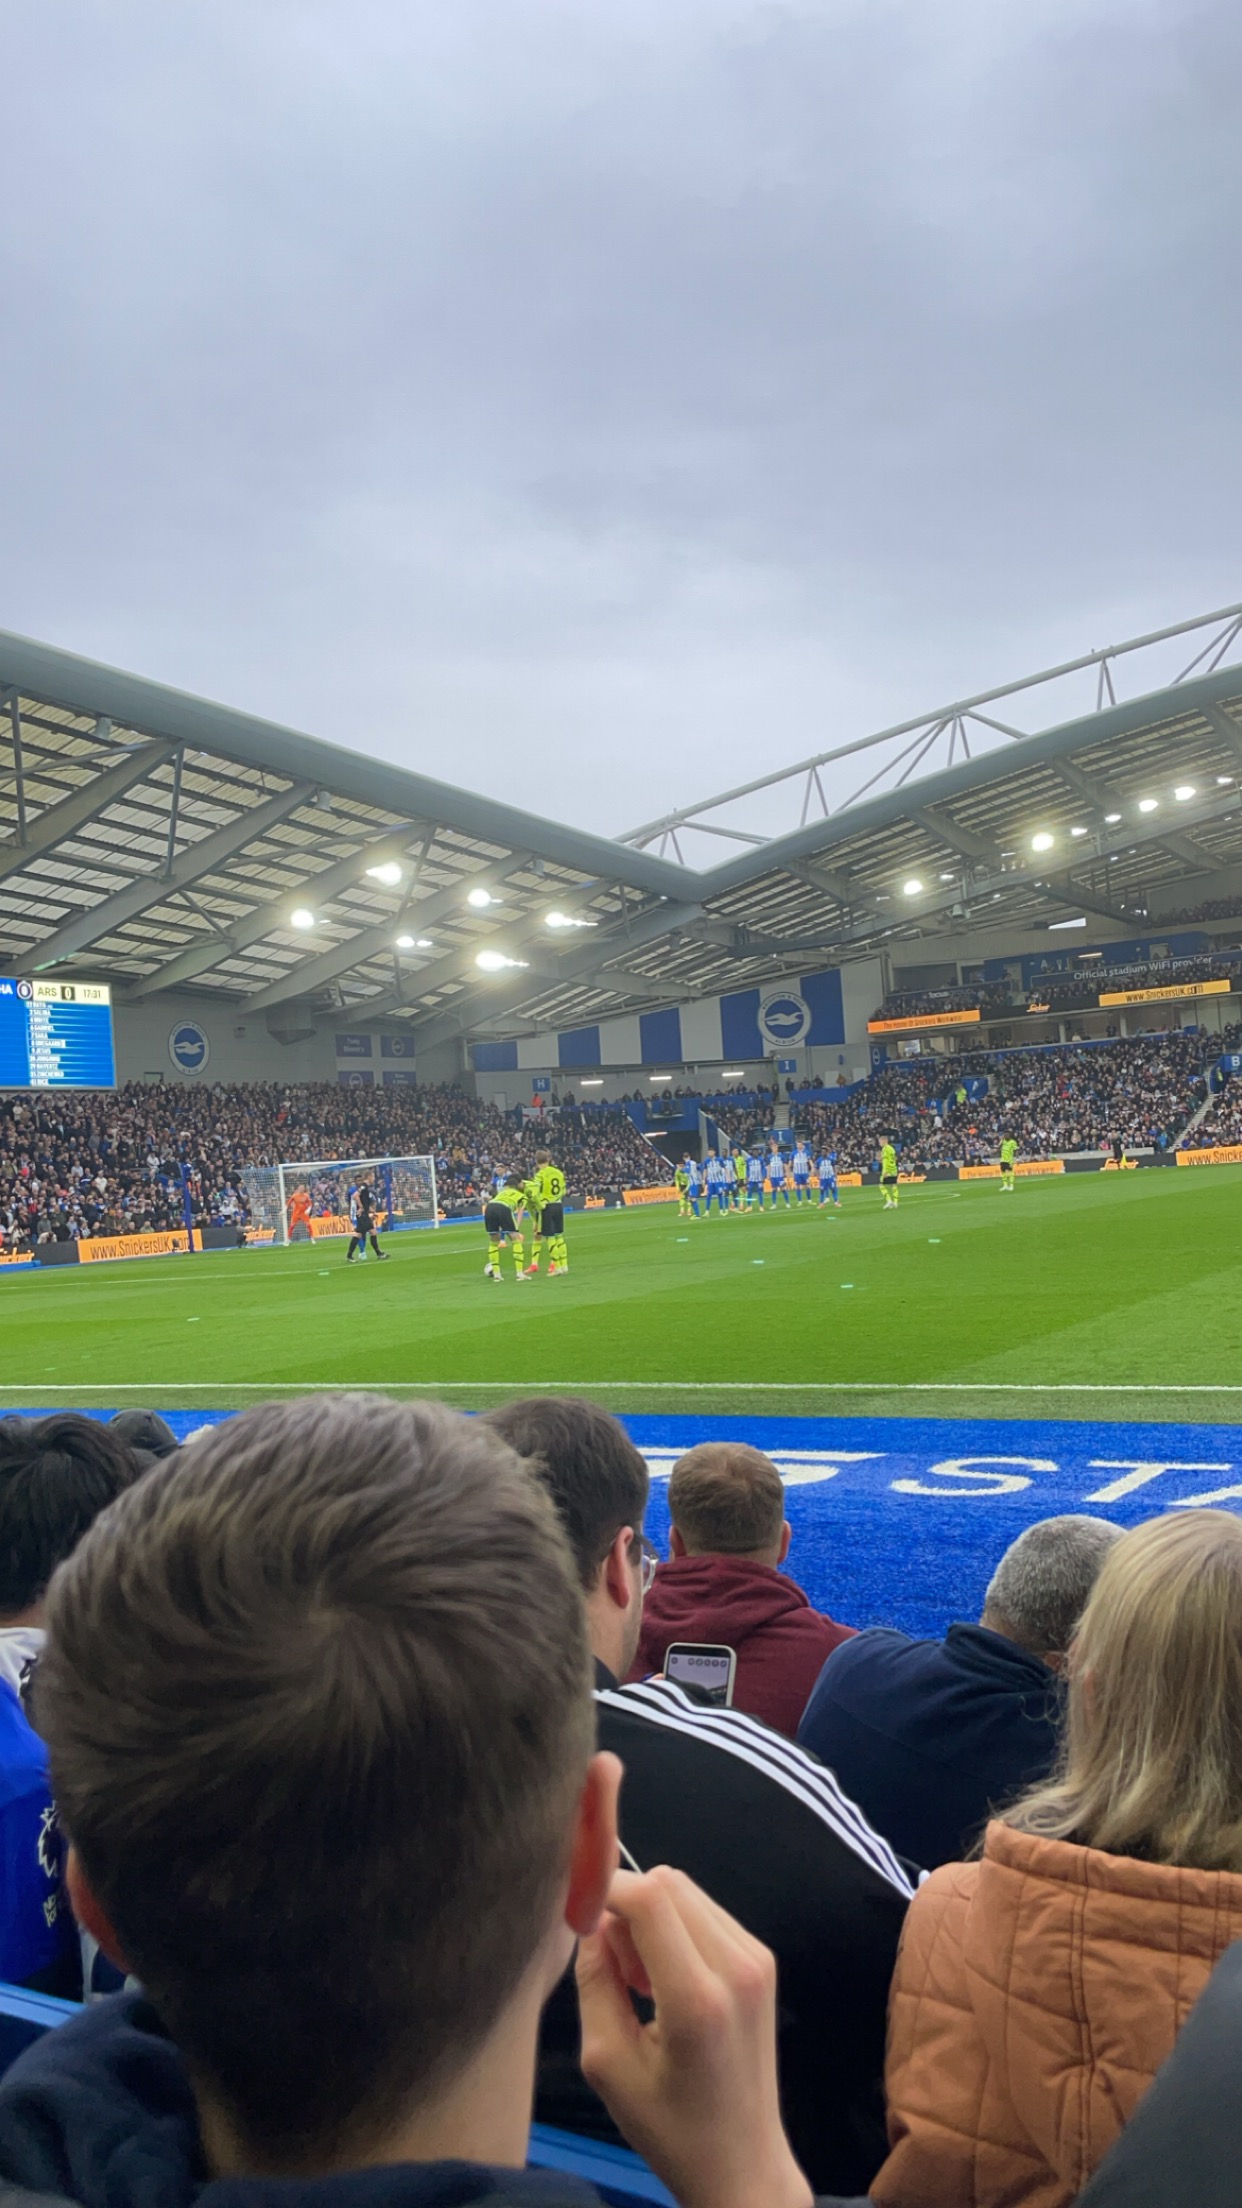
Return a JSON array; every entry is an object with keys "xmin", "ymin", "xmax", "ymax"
[{"xmin": 537, "ymin": 1665, "xmax": 911, "ymax": 2195}]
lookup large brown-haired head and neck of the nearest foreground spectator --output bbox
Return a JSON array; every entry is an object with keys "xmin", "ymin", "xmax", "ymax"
[{"xmin": 40, "ymin": 1395, "xmax": 619, "ymax": 2175}]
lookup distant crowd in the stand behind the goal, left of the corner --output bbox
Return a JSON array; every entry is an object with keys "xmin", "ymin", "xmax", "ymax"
[{"xmin": 0, "ymin": 1082, "xmax": 672, "ymax": 1250}]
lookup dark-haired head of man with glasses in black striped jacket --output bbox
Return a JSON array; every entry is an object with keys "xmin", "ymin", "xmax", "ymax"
[{"xmin": 484, "ymin": 1395, "xmax": 650, "ymax": 1678}]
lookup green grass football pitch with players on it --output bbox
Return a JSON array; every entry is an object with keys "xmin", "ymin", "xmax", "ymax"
[{"xmin": 0, "ymin": 1168, "xmax": 1242, "ymax": 1420}]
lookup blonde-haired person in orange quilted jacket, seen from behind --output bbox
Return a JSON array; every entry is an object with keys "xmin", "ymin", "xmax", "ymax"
[{"xmin": 871, "ymin": 1510, "xmax": 1242, "ymax": 2208}]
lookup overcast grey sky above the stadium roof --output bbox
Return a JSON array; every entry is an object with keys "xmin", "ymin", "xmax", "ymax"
[{"xmin": 0, "ymin": 0, "xmax": 1242, "ymax": 832}]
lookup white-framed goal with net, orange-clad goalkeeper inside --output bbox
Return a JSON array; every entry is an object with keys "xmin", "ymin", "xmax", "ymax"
[{"xmin": 241, "ymin": 1157, "xmax": 440, "ymax": 1243}]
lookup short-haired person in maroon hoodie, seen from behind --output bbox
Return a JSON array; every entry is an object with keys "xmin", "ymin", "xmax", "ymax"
[{"xmin": 630, "ymin": 1442, "xmax": 853, "ymax": 1740}]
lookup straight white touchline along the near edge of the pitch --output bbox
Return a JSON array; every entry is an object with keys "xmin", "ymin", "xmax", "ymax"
[{"xmin": 0, "ymin": 1380, "xmax": 1242, "ymax": 1395}]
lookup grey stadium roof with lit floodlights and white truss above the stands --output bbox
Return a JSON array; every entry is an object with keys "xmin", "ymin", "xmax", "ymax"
[{"xmin": 0, "ymin": 605, "xmax": 1242, "ymax": 1040}]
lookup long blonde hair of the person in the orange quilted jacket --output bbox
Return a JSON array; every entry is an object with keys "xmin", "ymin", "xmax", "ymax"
[{"xmin": 1006, "ymin": 1510, "xmax": 1242, "ymax": 1870}]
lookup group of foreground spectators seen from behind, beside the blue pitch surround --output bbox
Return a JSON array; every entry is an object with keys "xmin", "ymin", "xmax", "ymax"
[{"xmin": 0, "ymin": 1395, "xmax": 1242, "ymax": 2208}]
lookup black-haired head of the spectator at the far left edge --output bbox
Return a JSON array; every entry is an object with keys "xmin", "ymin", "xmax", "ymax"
[{"xmin": 0, "ymin": 1411, "xmax": 144, "ymax": 1625}]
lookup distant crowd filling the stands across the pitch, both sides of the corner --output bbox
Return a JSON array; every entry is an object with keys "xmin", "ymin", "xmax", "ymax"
[{"xmin": 0, "ymin": 1029, "xmax": 1242, "ymax": 1252}]
